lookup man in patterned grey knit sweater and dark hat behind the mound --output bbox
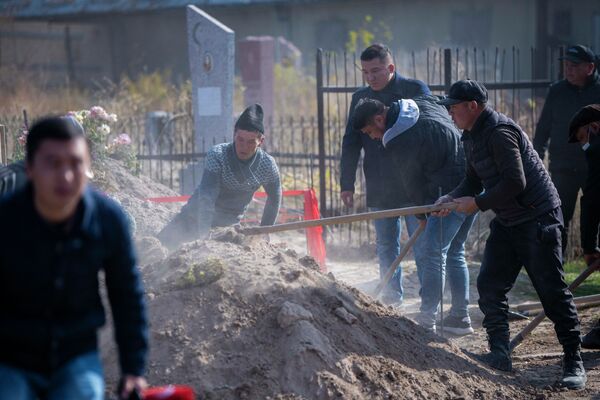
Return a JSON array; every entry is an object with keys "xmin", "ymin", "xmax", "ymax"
[{"xmin": 158, "ymin": 104, "xmax": 281, "ymax": 249}]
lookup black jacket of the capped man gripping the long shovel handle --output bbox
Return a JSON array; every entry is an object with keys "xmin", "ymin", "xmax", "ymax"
[{"xmin": 450, "ymin": 107, "xmax": 560, "ymax": 226}]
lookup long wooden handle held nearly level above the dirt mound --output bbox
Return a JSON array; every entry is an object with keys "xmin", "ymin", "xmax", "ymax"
[{"xmin": 240, "ymin": 203, "xmax": 457, "ymax": 235}]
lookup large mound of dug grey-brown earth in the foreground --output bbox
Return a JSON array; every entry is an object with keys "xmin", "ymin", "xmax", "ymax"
[{"xmin": 101, "ymin": 159, "xmax": 535, "ymax": 399}]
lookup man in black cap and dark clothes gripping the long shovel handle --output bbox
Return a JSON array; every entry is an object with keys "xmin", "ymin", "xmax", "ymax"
[{"xmin": 437, "ymin": 80, "xmax": 586, "ymax": 389}]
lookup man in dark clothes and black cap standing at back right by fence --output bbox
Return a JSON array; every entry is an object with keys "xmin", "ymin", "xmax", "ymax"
[{"xmin": 533, "ymin": 45, "xmax": 600, "ymax": 251}]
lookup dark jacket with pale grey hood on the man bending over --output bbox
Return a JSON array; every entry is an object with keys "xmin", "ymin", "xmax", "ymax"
[{"xmin": 385, "ymin": 96, "xmax": 465, "ymax": 206}]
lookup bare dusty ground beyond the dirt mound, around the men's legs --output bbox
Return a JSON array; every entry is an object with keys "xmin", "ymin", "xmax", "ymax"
[{"xmin": 328, "ymin": 255, "xmax": 600, "ymax": 399}]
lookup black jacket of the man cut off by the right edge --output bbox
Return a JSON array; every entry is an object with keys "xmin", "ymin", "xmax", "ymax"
[{"xmin": 580, "ymin": 136, "xmax": 600, "ymax": 254}]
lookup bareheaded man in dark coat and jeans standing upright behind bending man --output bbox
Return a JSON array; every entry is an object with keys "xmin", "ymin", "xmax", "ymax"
[{"xmin": 340, "ymin": 44, "xmax": 430, "ymax": 304}]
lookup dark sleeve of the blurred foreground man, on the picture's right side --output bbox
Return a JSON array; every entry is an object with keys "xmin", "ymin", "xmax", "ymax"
[{"xmin": 103, "ymin": 205, "xmax": 148, "ymax": 376}]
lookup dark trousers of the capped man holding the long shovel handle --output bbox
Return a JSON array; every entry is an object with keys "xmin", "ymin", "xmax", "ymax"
[{"xmin": 477, "ymin": 208, "xmax": 580, "ymax": 348}]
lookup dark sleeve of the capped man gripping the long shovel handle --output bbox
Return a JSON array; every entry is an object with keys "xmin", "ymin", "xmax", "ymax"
[{"xmin": 475, "ymin": 128, "xmax": 526, "ymax": 211}]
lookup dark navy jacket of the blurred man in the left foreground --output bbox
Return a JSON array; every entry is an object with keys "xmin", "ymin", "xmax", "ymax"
[{"xmin": 0, "ymin": 185, "xmax": 147, "ymax": 375}]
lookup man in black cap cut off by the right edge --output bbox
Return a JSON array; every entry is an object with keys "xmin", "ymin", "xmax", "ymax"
[{"xmin": 569, "ymin": 104, "xmax": 600, "ymax": 349}]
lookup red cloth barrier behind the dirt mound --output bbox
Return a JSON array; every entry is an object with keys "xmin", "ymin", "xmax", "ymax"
[{"xmin": 146, "ymin": 189, "xmax": 327, "ymax": 273}]
